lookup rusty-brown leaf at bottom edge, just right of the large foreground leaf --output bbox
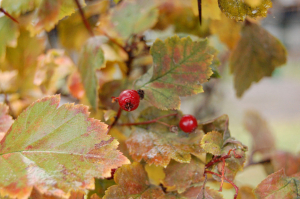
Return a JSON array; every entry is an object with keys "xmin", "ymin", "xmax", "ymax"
[{"xmin": 103, "ymin": 162, "xmax": 164, "ymax": 199}]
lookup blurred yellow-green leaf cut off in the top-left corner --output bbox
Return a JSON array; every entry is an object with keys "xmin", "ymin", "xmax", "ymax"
[{"xmin": 0, "ymin": 0, "xmax": 43, "ymax": 16}]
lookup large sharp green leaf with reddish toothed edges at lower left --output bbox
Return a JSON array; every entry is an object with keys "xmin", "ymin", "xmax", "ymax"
[{"xmin": 0, "ymin": 95, "xmax": 129, "ymax": 198}]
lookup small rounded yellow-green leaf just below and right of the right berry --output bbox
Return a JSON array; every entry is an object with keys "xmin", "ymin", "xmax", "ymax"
[{"xmin": 201, "ymin": 131, "xmax": 223, "ymax": 156}]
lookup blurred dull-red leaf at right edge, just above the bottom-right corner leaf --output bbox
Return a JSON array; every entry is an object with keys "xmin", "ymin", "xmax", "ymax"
[{"xmin": 272, "ymin": 151, "xmax": 300, "ymax": 176}]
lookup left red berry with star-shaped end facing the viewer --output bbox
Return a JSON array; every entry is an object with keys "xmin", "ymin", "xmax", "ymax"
[{"xmin": 118, "ymin": 90, "xmax": 140, "ymax": 111}]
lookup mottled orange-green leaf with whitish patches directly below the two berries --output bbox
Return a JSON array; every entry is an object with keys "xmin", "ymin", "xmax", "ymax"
[{"xmin": 126, "ymin": 107, "xmax": 204, "ymax": 167}]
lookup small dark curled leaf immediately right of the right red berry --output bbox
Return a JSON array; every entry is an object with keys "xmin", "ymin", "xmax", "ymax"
[{"xmin": 199, "ymin": 115, "xmax": 230, "ymax": 141}]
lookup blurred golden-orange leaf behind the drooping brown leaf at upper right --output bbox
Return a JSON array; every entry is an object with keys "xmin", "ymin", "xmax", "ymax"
[{"xmin": 210, "ymin": 14, "xmax": 242, "ymax": 50}]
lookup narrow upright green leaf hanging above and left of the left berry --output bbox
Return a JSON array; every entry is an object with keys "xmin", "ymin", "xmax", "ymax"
[{"xmin": 78, "ymin": 36, "xmax": 105, "ymax": 110}]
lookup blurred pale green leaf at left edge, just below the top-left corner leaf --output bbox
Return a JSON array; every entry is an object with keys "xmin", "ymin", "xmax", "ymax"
[{"xmin": 0, "ymin": 15, "xmax": 20, "ymax": 61}]
